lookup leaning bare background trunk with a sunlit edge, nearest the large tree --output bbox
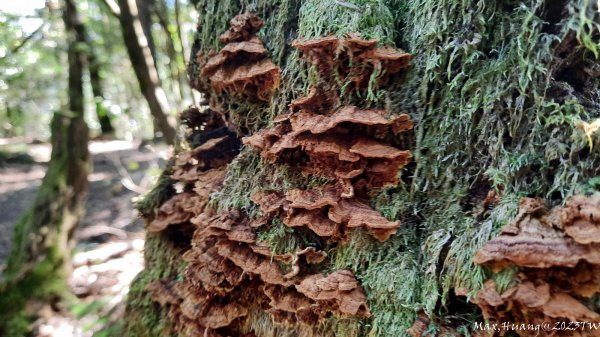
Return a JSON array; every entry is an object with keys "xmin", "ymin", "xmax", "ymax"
[{"xmin": 119, "ymin": 0, "xmax": 175, "ymax": 144}]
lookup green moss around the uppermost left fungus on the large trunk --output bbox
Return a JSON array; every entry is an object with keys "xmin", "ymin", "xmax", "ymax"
[{"xmin": 190, "ymin": 0, "xmax": 300, "ymax": 133}]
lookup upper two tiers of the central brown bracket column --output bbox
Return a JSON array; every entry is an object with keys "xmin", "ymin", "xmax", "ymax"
[{"xmin": 243, "ymin": 35, "xmax": 413, "ymax": 192}]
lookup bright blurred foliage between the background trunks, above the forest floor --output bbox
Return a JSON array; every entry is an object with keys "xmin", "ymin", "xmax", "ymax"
[{"xmin": 0, "ymin": 0, "xmax": 197, "ymax": 141}]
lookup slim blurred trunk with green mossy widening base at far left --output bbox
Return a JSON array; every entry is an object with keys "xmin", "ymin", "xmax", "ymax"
[{"xmin": 0, "ymin": 0, "xmax": 90, "ymax": 336}]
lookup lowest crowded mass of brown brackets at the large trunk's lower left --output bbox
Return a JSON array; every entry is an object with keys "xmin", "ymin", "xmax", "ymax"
[{"xmin": 147, "ymin": 178, "xmax": 369, "ymax": 330}]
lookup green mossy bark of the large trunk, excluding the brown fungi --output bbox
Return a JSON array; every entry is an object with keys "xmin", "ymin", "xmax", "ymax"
[{"xmin": 128, "ymin": 0, "xmax": 600, "ymax": 337}]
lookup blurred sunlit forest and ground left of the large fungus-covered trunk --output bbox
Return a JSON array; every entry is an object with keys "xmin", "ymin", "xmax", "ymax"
[{"xmin": 0, "ymin": 0, "xmax": 200, "ymax": 337}]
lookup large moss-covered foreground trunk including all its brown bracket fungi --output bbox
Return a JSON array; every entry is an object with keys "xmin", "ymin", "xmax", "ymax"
[{"xmin": 127, "ymin": 0, "xmax": 600, "ymax": 336}]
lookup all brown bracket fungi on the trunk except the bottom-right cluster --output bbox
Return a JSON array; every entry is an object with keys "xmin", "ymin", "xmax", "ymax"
[{"xmin": 141, "ymin": 13, "xmax": 412, "ymax": 336}]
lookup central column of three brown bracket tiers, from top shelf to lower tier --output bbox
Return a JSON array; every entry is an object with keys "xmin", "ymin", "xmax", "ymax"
[{"xmin": 243, "ymin": 30, "xmax": 413, "ymax": 242}]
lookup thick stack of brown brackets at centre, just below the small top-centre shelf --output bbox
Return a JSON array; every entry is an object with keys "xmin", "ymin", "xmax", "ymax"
[{"xmin": 243, "ymin": 106, "xmax": 412, "ymax": 188}]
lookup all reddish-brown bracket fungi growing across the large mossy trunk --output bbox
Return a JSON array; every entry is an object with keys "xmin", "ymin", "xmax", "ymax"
[{"xmin": 142, "ymin": 7, "xmax": 600, "ymax": 337}]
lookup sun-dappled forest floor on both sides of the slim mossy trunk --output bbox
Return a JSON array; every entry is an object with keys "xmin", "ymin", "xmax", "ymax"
[{"xmin": 0, "ymin": 139, "xmax": 169, "ymax": 337}]
